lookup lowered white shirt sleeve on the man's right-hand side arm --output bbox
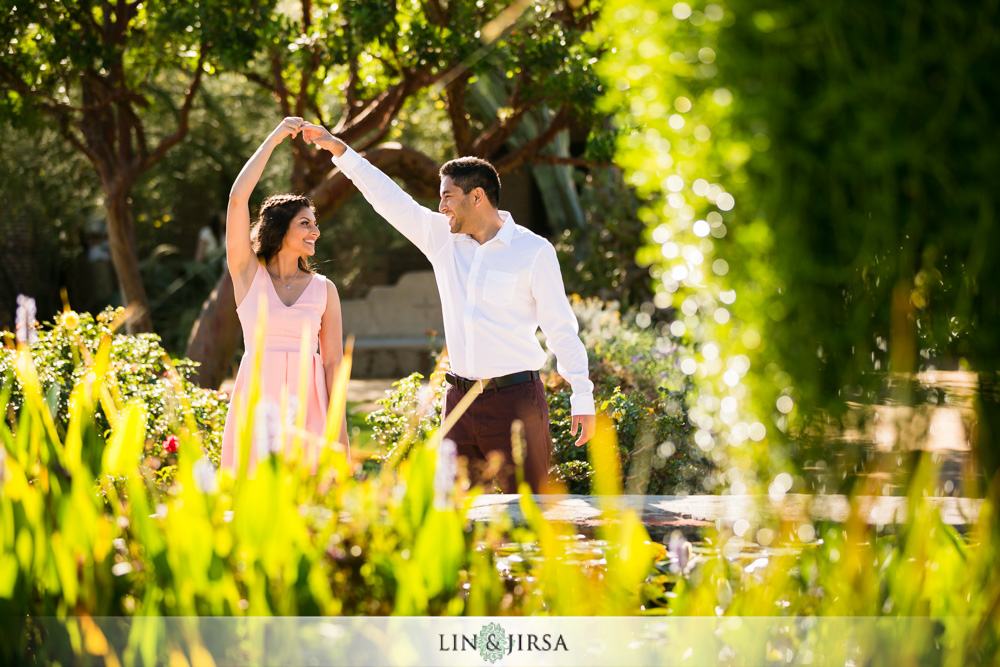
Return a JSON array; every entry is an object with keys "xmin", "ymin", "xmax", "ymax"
[{"xmin": 531, "ymin": 243, "xmax": 596, "ymax": 415}]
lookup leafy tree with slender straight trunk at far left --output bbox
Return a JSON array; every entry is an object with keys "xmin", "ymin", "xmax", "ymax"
[{"xmin": 0, "ymin": 0, "xmax": 271, "ymax": 332}]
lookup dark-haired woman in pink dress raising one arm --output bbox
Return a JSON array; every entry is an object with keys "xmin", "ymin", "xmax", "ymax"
[{"xmin": 222, "ymin": 118, "xmax": 348, "ymax": 473}]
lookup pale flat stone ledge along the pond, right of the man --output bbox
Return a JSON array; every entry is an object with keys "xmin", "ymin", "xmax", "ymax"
[{"xmin": 469, "ymin": 494, "xmax": 982, "ymax": 540}]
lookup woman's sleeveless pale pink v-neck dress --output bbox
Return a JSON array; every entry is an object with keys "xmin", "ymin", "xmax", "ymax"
[{"xmin": 221, "ymin": 264, "xmax": 329, "ymax": 472}]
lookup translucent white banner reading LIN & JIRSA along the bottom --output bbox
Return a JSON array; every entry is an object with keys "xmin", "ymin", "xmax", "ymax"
[{"xmin": 35, "ymin": 616, "xmax": 969, "ymax": 667}]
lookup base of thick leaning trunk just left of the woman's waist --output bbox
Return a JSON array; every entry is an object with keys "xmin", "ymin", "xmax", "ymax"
[{"xmin": 184, "ymin": 270, "xmax": 242, "ymax": 389}]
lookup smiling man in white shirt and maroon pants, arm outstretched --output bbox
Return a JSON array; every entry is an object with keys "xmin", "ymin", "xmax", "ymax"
[{"xmin": 303, "ymin": 125, "xmax": 596, "ymax": 493}]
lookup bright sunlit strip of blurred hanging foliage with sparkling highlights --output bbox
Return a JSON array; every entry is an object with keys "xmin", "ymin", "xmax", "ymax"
[{"xmin": 595, "ymin": 2, "xmax": 780, "ymax": 489}]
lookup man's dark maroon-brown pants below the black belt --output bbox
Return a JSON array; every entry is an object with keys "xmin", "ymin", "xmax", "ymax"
[{"xmin": 442, "ymin": 380, "xmax": 552, "ymax": 493}]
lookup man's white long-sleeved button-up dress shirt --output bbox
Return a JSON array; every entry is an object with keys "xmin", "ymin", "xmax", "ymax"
[{"xmin": 333, "ymin": 148, "xmax": 595, "ymax": 415}]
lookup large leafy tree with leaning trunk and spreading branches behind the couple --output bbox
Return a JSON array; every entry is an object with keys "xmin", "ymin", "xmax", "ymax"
[{"xmin": 187, "ymin": 0, "xmax": 600, "ymax": 386}]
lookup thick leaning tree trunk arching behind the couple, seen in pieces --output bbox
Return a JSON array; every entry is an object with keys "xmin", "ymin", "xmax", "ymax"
[{"xmin": 185, "ymin": 144, "xmax": 439, "ymax": 389}]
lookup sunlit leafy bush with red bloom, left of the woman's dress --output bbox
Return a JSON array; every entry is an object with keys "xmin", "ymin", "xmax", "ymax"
[{"xmin": 0, "ymin": 308, "xmax": 229, "ymax": 470}]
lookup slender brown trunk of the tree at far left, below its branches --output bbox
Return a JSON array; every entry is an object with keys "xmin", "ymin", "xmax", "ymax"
[{"xmin": 104, "ymin": 188, "xmax": 153, "ymax": 334}]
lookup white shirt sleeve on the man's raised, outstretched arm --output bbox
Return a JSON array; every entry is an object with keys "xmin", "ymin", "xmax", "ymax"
[{"xmin": 333, "ymin": 147, "xmax": 451, "ymax": 260}]
